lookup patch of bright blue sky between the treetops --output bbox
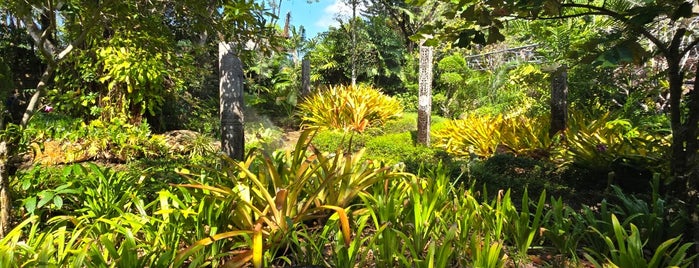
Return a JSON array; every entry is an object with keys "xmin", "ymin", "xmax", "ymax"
[{"xmin": 279, "ymin": 0, "xmax": 352, "ymax": 39}]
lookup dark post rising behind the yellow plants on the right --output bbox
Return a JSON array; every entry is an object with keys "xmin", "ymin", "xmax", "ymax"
[{"xmin": 549, "ymin": 65, "xmax": 568, "ymax": 137}]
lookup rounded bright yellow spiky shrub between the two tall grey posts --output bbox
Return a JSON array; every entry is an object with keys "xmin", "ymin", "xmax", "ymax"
[{"xmin": 300, "ymin": 85, "xmax": 403, "ymax": 132}]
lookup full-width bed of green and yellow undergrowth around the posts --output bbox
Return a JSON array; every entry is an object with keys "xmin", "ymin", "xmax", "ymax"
[{"xmin": 0, "ymin": 85, "xmax": 696, "ymax": 267}]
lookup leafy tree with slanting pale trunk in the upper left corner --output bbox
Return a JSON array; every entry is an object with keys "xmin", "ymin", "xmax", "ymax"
[{"xmin": 0, "ymin": 1, "xmax": 274, "ymax": 237}]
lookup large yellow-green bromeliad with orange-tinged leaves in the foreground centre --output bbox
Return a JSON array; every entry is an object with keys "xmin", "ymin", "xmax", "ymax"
[{"xmin": 176, "ymin": 129, "xmax": 406, "ymax": 265}]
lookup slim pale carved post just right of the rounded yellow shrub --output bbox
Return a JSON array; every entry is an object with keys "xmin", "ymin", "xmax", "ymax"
[{"xmin": 417, "ymin": 45, "xmax": 433, "ymax": 146}]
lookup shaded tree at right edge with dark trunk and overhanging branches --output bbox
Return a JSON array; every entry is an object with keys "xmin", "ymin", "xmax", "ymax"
[{"xmin": 416, "ymin": 0, "xmax": 699, "ymax": 258}]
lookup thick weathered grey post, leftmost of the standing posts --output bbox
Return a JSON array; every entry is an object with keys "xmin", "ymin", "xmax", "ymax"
[{"xmin": 218, "ymin": 42, "xmax": 245, "ymax": 161}]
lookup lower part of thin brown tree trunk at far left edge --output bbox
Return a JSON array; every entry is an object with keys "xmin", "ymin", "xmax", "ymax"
[{"xmin": 0, "ymin": 141, "xmax": 12, "ymax": 238}]
